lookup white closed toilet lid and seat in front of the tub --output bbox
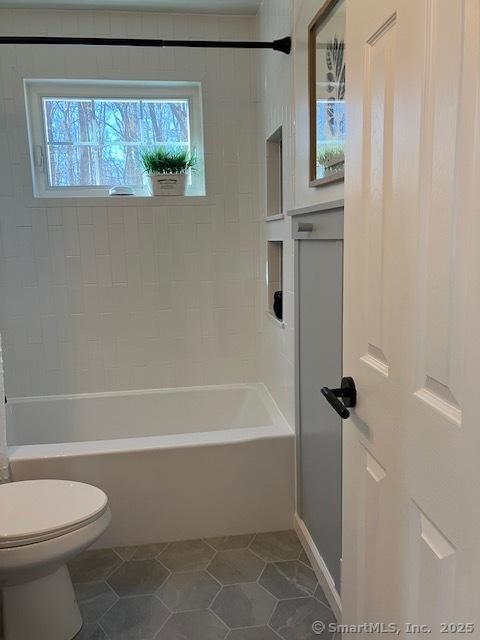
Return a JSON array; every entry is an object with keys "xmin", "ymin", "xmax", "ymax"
[{"xmin": 0, "ymin": 480, "xmax": 108, "ymax": 549}]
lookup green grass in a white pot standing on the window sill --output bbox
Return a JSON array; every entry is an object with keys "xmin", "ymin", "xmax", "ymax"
[{"xmin": 142, "ymin": 147, "xmax": 197, "ymax": 196}]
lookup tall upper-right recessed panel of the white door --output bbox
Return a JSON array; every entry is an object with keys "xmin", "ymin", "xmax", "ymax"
[{"xmin": 415, "ymin": 0, "xmax": 465, "ymax": 426}]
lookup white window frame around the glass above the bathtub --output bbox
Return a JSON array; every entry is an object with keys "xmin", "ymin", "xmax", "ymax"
[{"xmin": 24, "ymin": 79, "xmax": 205, "ymax": 198}]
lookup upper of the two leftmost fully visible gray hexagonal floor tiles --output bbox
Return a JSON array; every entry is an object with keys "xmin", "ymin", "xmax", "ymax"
[{"xmin": 107, "ymin": 560, "xmax": 169, "ymax": 596}]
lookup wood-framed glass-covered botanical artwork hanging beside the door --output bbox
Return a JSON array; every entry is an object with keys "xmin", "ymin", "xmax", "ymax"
[{"xmin": 308, "ymin": 0, "xmax": 346, "ymax": 187}]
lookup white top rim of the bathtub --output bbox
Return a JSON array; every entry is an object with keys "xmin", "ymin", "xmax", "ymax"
[{"xmin": 7, "ymin": 382, "xmax": 294, "ymax": 462}]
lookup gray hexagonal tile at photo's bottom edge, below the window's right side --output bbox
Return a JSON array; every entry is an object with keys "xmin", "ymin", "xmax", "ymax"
[{"xmin": 155, "ymin": 611, "xmax": 228, "ymax": 640}]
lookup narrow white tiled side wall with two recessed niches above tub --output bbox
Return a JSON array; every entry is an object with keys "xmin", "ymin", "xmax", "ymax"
[{"xmin": 256, "ymin": 0, "xmax": 295, "ymax": 425}]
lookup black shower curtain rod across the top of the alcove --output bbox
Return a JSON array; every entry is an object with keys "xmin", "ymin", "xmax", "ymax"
[{"xmin": 0, "ymin": 36, "xmax": 292, "ymax": 55}]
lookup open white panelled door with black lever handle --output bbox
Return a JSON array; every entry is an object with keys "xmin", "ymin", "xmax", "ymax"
[{"xmin": 342, "ymin": 0, "xmax": 480, "ymax": 638}]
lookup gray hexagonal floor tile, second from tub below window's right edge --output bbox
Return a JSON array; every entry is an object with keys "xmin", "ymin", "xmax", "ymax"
[{"xmin": 156, "ymin": 571, "xmax": 221, "ymax": 611}]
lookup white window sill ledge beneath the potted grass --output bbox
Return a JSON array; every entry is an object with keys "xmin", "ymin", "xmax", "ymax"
[{"xmin": 31, "ymin": 195, "xmax": 214, "ymax": 207}]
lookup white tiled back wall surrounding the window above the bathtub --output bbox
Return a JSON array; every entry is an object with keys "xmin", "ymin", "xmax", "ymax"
[{"xmin": 0, "ymin": 10, "xmax": 262, "ymax": 399}]
